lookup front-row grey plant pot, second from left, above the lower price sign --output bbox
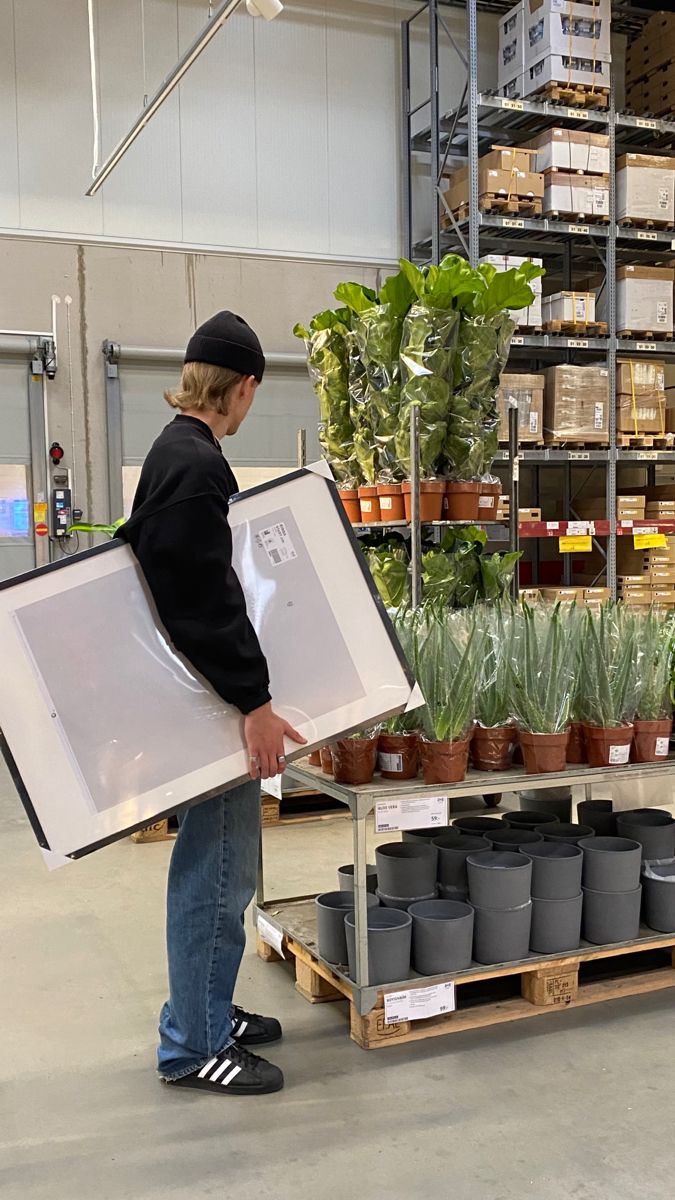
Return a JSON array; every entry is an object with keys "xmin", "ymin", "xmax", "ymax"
[{"xmin": 408, "ymin": 900, "xmax": 473, "ymax": 974}]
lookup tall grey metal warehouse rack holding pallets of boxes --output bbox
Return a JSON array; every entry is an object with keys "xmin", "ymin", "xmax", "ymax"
[{"xmin": 401, "ymin": 0, "xmax": 675, "ymax": 598}]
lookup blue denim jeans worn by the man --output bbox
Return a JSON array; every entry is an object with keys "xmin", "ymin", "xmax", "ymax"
[{"xmin": 157, "ymin": 780, "xmax": 261, "ymax": 1079}]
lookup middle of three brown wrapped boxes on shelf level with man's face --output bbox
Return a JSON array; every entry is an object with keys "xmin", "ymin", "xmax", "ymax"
[{"xmin": 544, "ymin": 365, "xmax": 609, "ymax": 445}]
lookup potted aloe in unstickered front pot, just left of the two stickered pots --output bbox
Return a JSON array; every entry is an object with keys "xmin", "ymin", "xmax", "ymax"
[{"xmin": 509, "ymin": 604, "xmax": 573, "ymax": 775}]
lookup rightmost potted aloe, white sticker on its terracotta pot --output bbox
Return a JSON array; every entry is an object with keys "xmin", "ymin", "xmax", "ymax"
[{"xmin": 631, "ymin": 610, "xmax": 675, "ymax": 762}]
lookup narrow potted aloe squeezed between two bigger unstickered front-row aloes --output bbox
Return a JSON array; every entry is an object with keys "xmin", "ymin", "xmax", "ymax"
[{"xmin": 471, "ymin": 605, "xmax": 515, "ymax": 770}]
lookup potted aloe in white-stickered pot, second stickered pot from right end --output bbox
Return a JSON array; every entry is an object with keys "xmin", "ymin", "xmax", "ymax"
[{"xmin": 579, "ymin": 601, "xmax": 643, "ymax": 767}]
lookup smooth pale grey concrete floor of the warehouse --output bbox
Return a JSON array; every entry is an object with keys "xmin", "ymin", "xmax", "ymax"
[{"xmin": 0, "ymin": 768, "xmax": 675, "ymax": 1200}]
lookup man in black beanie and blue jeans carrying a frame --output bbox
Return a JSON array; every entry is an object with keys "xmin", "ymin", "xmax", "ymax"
[{"xmin": 120, "ymin": 312, "xmax": 305, "ymax": 1096}]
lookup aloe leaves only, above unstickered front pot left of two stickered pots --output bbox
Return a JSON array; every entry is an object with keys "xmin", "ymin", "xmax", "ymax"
[{"xmin": 508, "ymin": 604, "xmax": 573, "ymax": 733}]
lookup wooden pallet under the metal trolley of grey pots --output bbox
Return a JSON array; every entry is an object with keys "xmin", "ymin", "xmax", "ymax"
[{"xmin": 257, "ymin": 930, "xmax": 675, "ymax": 1050}]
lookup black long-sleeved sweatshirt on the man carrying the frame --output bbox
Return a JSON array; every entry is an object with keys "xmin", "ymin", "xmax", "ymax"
[{"xmin": 119, "ymin": 415, "xmax": 270, "ymax": 713}]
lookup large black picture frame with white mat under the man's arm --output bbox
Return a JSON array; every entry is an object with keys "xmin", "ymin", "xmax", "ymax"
[{"xmin": 0, "ymin": 470, "xmax": 413, "ymax": 858}]
